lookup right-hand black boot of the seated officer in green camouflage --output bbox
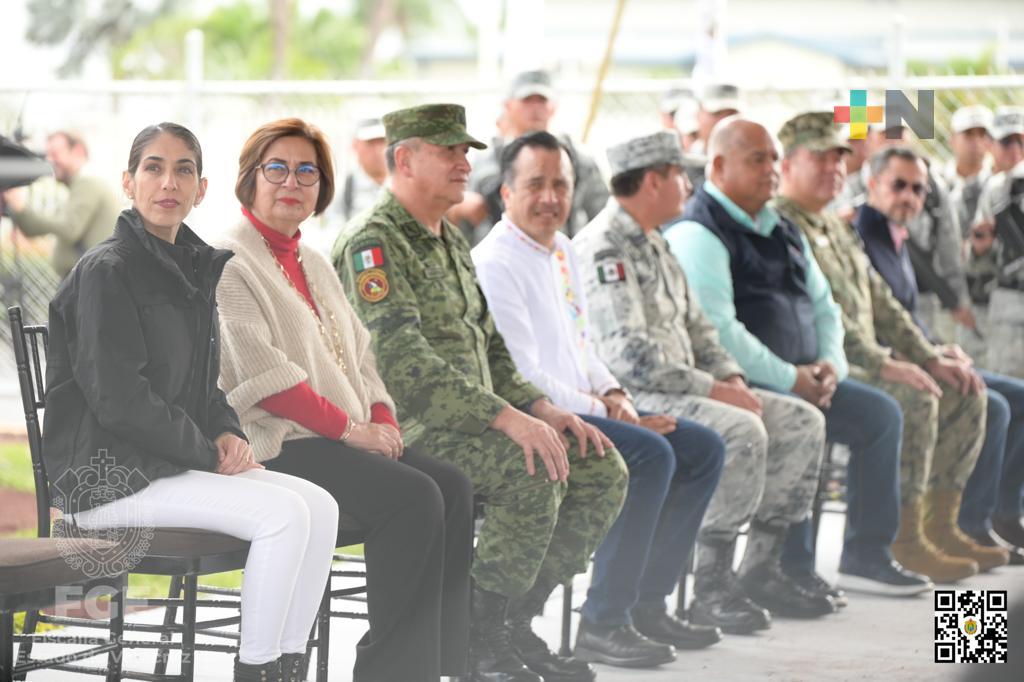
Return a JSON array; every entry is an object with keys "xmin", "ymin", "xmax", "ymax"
[{"xmin": 505, "ymin": 579, "xmax": 597, "ymax": 682}]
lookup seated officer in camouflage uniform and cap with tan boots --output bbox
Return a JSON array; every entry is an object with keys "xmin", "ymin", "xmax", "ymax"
[{"xmin": 776, "ymin": 113, "xmax": 1006, "ymax": 582}]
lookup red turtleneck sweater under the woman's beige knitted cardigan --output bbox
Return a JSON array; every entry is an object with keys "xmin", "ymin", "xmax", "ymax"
[{"xmin": 242, "ymin": 207, "xmax": 398, "ymax": 440}]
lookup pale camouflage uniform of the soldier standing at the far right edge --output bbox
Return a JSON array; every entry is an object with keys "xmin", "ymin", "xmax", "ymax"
[{"xmin": 973, "ymin": 163, "xmax": 1024, "ymax": 379}]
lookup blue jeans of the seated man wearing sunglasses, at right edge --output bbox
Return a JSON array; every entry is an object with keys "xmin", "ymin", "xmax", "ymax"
[{"xmin": 959, "ymin": 370, "xmax": 1024, "ymax": 535}]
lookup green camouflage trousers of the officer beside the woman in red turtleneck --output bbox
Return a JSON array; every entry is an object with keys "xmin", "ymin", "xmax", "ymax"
[{"xmin": 415, "ymin": 429, "xmax": 629, "ymax": 597}]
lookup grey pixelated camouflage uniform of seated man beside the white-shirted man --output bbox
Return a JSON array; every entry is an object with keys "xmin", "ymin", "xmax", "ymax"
[{"xmin": 572, "ymin": 199, "xmax": 825, "ymax": 541}]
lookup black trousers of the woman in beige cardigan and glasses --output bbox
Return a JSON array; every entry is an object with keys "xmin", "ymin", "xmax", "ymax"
[{"xmin": 264, "ymin": 438, "xmax": 473, "ymax": 682}]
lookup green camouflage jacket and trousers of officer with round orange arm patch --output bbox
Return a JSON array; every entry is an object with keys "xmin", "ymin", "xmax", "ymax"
[{"xmin": 332, "ymin": 189, "xmax": 628, "ymax": 596}]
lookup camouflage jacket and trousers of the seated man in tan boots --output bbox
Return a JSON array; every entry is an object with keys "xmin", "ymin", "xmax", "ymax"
[{"xmin": 776, "ymin": 197, "xmax": 985, "ymax": 504}]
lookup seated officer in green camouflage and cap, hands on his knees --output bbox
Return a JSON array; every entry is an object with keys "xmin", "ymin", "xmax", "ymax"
[{"xmin": 332, "ymin": 104, "xmax": 628, "ymax": 682}]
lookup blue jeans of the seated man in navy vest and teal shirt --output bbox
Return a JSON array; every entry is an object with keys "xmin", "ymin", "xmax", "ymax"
[{"xmin": 782, "ymin": 379, "xmax": 903, "ymax": 573}]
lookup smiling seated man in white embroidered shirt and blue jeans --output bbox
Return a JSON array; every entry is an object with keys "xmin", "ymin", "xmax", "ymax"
[{"xmin": 472, "ymin": 131, "xmax": 725, "ymax": 667}]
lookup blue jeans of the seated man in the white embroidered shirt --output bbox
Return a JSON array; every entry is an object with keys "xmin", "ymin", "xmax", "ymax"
[{"xmin": 581, "ymin": 405, "xmax": 725, "ymax": 626}]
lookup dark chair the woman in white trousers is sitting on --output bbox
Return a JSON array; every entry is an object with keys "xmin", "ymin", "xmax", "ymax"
[{"xmin": 7, "ymin": 306, "xmax": 330, "ymax": 682}]
